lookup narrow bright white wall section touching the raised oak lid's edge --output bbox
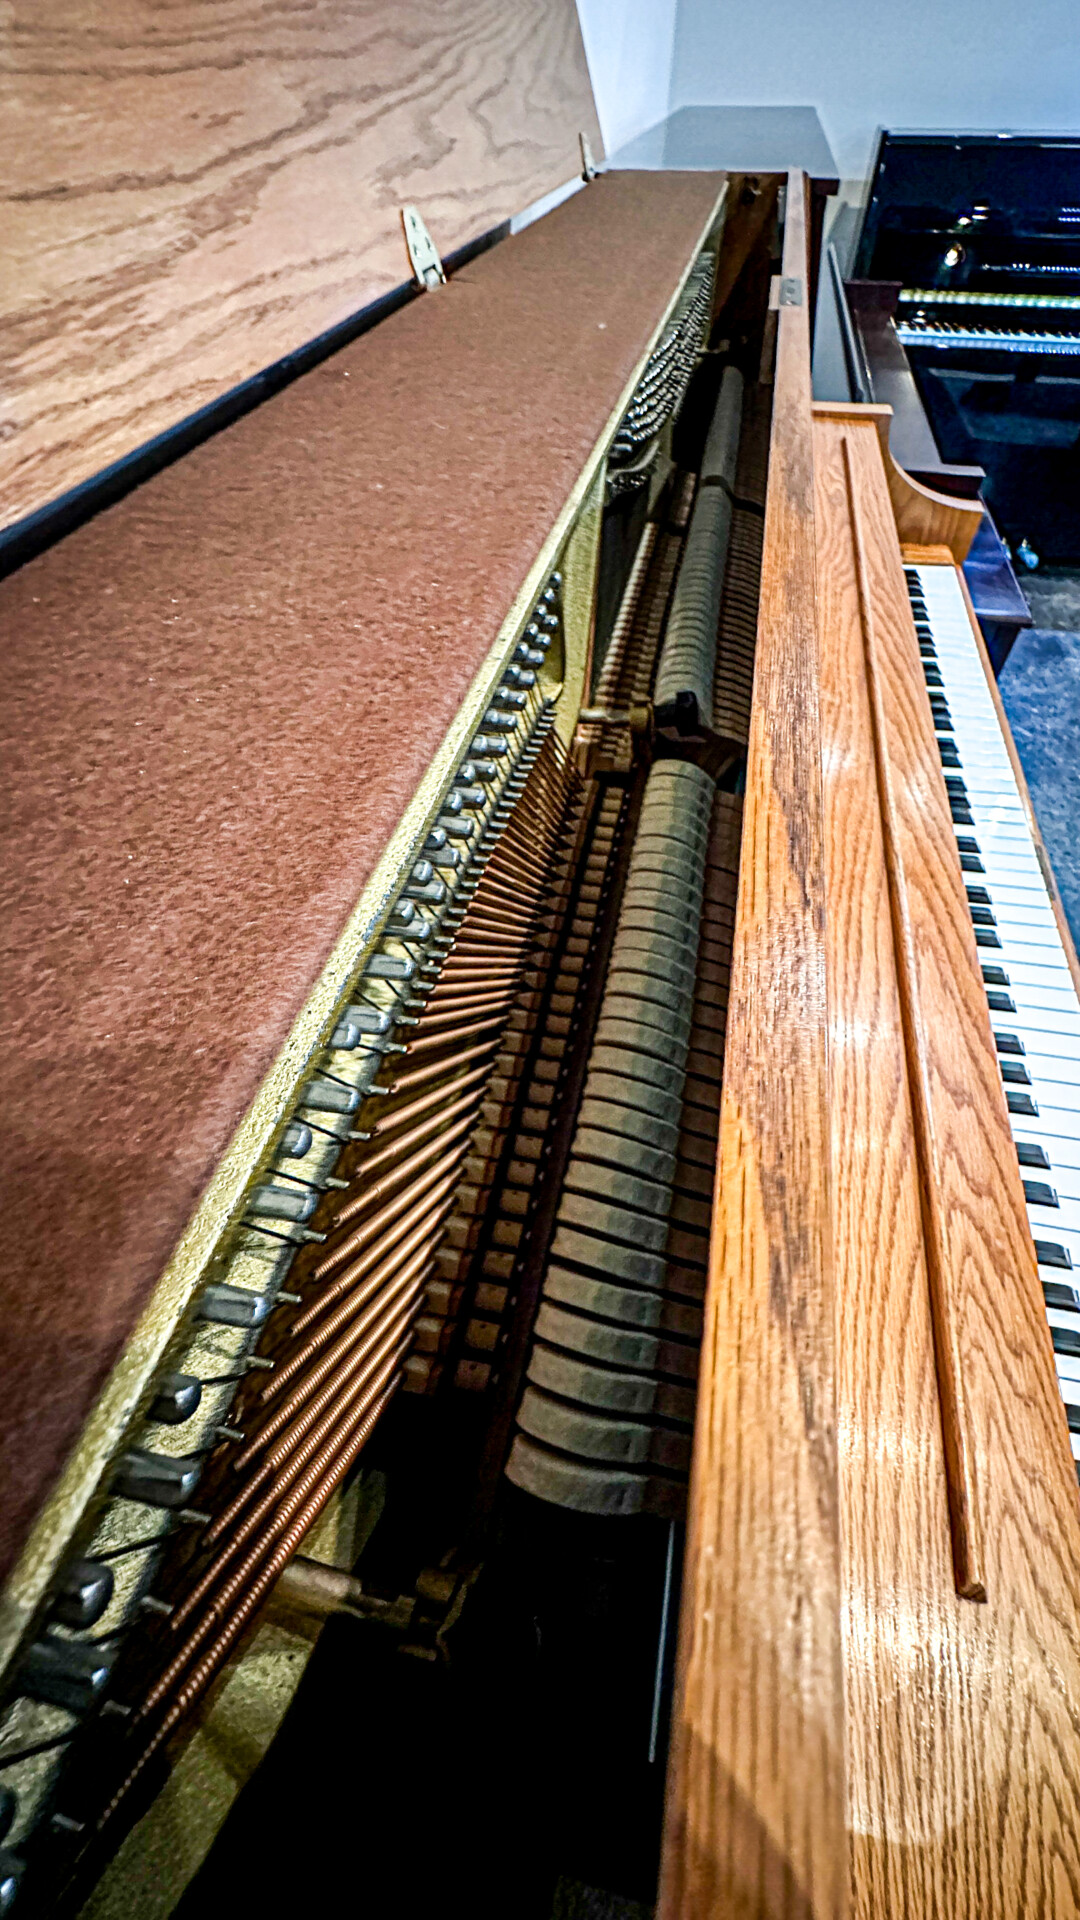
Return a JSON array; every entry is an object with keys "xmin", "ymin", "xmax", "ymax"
[{"xmin": 578, "ymin": 0, "xmax": 672, "ymax": 154}]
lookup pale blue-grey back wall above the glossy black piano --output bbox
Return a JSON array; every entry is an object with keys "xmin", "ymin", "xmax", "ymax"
[{"xmin": 664, "ymin": 0, "xmax": 1080, "ymax": 180}]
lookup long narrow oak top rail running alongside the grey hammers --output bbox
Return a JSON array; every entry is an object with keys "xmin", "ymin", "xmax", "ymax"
[{"xmin": 657, "ymin": 175, "xmax": 846, "ymax": 1920}]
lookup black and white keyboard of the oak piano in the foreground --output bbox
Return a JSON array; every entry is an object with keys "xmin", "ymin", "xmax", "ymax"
[{"xmin": 905, "ymin": 566, "xmax": 1080, "ymax": 1478}]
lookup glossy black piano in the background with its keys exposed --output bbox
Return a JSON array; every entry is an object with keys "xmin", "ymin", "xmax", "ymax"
[{"xmin": 847, "ymin": 132, "xmax": 1080, "ymax": 564}]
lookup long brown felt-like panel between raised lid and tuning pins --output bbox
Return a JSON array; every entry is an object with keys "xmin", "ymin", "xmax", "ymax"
[{"xmin": 0, "ymin": 173, "xmax": 719, "ymax": 1567}]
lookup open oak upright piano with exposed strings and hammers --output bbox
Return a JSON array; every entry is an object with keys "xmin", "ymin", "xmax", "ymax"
[{"xmin": 0, "ymin": 161, "xmax": 1080, "ymax": 1920}]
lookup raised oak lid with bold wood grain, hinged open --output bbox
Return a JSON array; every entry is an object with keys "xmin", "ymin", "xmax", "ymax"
[{"xmin": 0, "ymin": 0, "xmax": 601, "ymax": 524}]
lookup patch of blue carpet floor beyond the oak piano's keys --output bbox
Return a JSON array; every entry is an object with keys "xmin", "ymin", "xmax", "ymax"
[{"xmin": 997, "ymin": 570, "xmax": 1080, "ymax": 947}]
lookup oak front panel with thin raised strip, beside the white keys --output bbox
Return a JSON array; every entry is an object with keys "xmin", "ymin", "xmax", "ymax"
[{"xmin": 815, "ymin": 417, "xmax": 1080, "ymax": 1920}]
